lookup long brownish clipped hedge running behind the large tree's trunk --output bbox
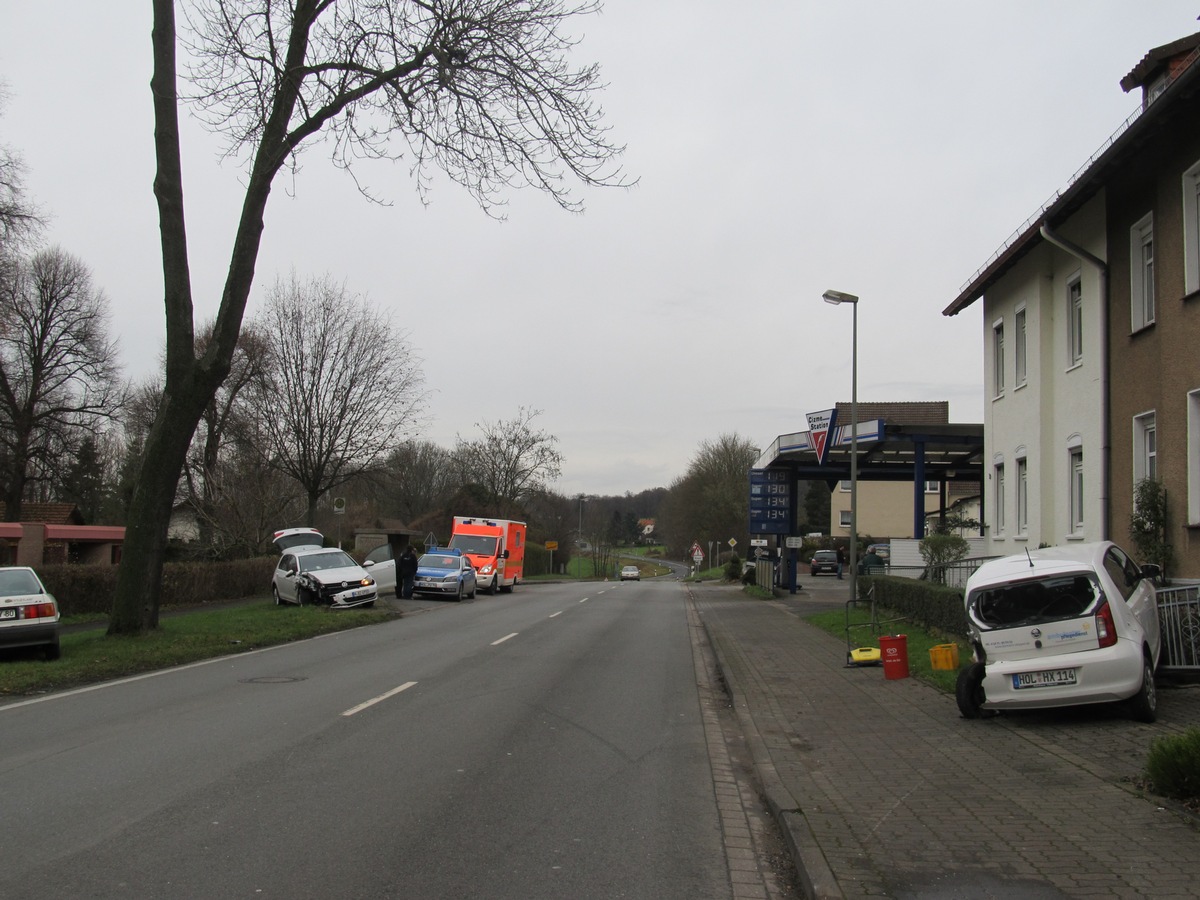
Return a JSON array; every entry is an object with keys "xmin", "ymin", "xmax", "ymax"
[{"xmin": 37, "ymin": 557, "xmax": 275, "ymax": 616}]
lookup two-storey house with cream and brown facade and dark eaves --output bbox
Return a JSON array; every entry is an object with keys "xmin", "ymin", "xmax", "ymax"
[{"xmin": 944, "ymin": 34, "xmax": 1200, "ymax": 577}]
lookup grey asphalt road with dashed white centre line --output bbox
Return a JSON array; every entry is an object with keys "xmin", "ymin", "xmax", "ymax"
[{"xmin": 0, "ymin": 582, "xmax": 732, "ymax": 900}]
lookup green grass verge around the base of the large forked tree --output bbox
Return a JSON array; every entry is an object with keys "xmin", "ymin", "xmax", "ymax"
[{"xmin": 0, "ymin": 601, "xmax": 396, "ymax": 697}]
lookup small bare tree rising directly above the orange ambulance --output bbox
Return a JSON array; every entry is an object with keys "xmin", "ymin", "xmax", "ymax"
[{"xmin": 455, "ymin": 407, "xmax": 563, "ymax": 516}]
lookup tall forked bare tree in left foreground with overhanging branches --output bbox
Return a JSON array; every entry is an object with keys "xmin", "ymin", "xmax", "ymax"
[{"xmin": 109, "ymin": 0, "xmax": 622, "ymax": 634}]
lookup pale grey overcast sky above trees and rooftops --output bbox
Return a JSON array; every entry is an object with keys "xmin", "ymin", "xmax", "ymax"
[{"xmin": 0, "ymin": 0, "xmax": 1200, "ymax": 496}]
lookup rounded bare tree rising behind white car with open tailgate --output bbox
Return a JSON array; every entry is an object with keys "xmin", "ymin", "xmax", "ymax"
[{"xmin": 250, "ymin": 275, "xmax": 425, "ymax": 523}]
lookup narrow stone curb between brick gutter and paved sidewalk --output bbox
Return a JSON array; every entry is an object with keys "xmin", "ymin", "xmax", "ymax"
[{"xmin": 688, "ymin": 587, "xmax": 846, "ymax": 900}]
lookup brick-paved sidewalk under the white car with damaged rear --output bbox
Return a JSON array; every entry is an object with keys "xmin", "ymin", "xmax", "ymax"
[{"xmin": 689, "ymin": 580, "xmax": 1200, "ymax": 900}]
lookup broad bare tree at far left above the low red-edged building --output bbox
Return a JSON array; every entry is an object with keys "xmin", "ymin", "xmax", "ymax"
[{"xmin": 0, "ymin": 248, "xmax": 122, "ymax": 522}]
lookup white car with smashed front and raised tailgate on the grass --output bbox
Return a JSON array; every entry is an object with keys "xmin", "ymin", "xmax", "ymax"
[{"xmin": 271, "ymin": 528, "xmax": 378, "ymax": 610}]
